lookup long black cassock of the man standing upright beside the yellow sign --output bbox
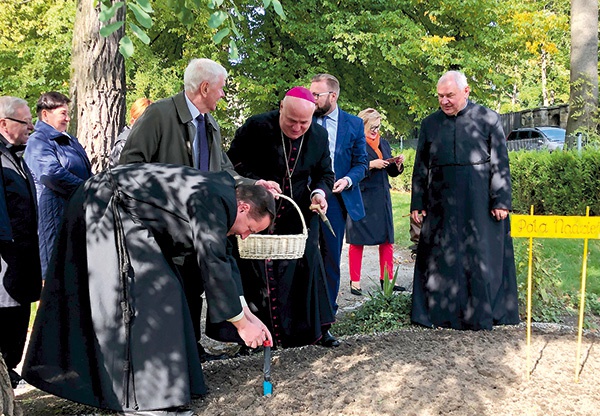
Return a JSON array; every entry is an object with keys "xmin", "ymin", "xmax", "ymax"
[{"xmin": 410, "ymin": 102, "xmax": 519, "ymax": 329}]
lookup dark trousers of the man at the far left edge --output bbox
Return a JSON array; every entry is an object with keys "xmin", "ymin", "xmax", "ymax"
[{"xmin": 0, "ymin": 303, "xmax": 31, "ymax": 370}]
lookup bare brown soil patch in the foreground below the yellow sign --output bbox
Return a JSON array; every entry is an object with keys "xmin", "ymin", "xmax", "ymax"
[{"xmin": 16, "ymin": 247, "xmax": 600, "ymax": 416}]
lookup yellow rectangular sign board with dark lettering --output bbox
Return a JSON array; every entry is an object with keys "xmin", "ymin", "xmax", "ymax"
[{"xmin": 510, "ymin": 214, "xmax": 600, "ymax": 239}]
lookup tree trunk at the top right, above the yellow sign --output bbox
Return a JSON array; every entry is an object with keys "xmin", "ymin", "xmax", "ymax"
[{"xmin": 567, "ymin": 0, "xmax": 598, "ymax": 140}]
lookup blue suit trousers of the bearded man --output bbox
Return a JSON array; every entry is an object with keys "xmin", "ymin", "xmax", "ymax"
[{"xmin": 320, "ymin": 194, "xmax": 349, "ymax": 314}]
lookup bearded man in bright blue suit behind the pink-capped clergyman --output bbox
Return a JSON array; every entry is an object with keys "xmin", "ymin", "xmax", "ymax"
[{"xmin": 310, "ymin": 74, "xmax": 369, "ymax": 347}]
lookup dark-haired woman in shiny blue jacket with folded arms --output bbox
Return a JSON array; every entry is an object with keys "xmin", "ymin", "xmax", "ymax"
[{"xmin": 25, "ymin": 92, "xmax": 92, "ymax": 278}]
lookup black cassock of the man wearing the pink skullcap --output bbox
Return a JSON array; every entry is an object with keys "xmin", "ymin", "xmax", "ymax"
[{"xmin": 228, "ymin": 111, "xmax": 334, "ymax": 347}]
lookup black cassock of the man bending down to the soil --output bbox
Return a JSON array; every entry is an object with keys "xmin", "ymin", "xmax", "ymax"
[{"xmin": 23, "ymin": 164, "xmax": 242, "ymax": 410}]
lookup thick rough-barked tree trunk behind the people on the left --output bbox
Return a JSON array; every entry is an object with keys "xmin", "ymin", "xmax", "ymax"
[{"xmin": 70, "ymin": 0, "xmax": 126, "ymax": 172}]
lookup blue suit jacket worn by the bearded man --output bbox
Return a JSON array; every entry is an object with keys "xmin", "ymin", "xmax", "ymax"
[{"xmin": 326, "ymin": 109, "xmax": 369, "ymax": 221}]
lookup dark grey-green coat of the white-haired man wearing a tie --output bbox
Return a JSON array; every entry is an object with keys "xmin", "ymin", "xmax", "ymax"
[{"xmin": 119, "ymin": 92, "xmax": 255, "ymax": 184}]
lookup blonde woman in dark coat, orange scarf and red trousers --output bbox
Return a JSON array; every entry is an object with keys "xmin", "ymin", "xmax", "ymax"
[{"xmin": 346, "ymin": 108, "xmax": 404, "ymax": 296}]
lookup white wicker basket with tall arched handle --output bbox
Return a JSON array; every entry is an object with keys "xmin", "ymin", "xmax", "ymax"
[{"xmin": 238, "ymin": 195, "xmax": 308, "ymax": 260}]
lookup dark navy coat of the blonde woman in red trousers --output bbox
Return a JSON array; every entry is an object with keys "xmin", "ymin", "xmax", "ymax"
[{"xmin": 346, "ymin": 139, "xmax": 404, "ymax": 246}]
